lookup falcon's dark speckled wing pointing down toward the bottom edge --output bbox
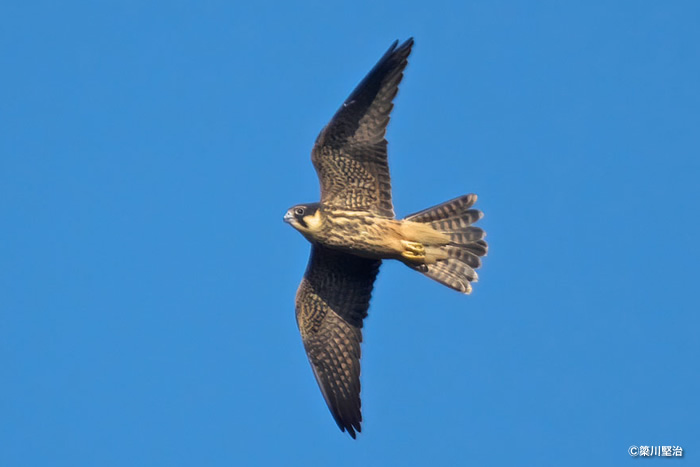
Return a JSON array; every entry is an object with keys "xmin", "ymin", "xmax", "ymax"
[{"xmin": 296, "ymin": 245, "xmax": 381, "ymax": 438}]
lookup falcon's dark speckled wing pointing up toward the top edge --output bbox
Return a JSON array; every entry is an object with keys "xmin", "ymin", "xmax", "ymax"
[{"xmin": 311, "ymin": 39, "xmax": 413, "ymax": 218}]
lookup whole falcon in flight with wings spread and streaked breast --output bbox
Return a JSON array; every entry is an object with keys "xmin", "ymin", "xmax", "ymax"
[{"xmin": 284, "ymin": 39, "xmax": 487, "ymax": 438}]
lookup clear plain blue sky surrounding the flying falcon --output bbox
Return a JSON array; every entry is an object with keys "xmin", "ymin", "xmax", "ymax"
[{"xmin": 0, "ymin": 0, "xmax": 700, "ymax": 467}]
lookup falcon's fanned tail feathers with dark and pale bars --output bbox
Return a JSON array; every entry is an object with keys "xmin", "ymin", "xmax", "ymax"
[{"xmin": 405, "ymin": 194, "xmax": 488, "ymax": 294}]
